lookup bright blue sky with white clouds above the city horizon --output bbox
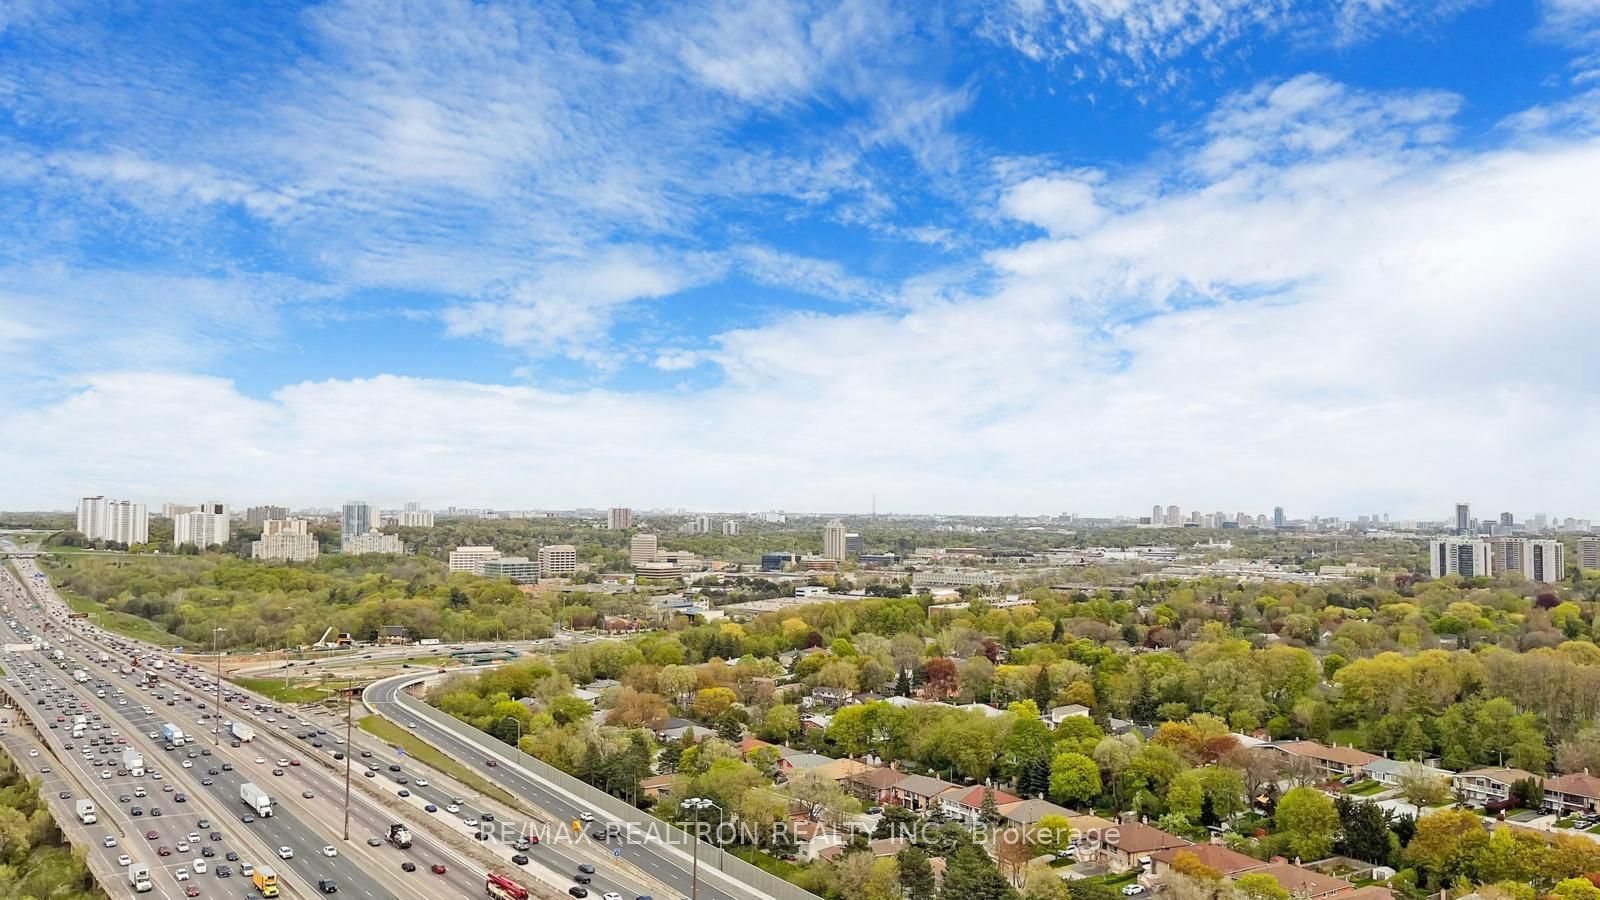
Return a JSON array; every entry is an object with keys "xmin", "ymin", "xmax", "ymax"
[{"xmin": 0, "ymin": 0, "xmax": 1600, "ymax": 517}]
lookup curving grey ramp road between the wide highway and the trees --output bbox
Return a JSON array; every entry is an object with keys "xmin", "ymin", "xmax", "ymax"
[{"xmin": 365, "ymin": 674, "xmax": 766, "ymax": 900}]
